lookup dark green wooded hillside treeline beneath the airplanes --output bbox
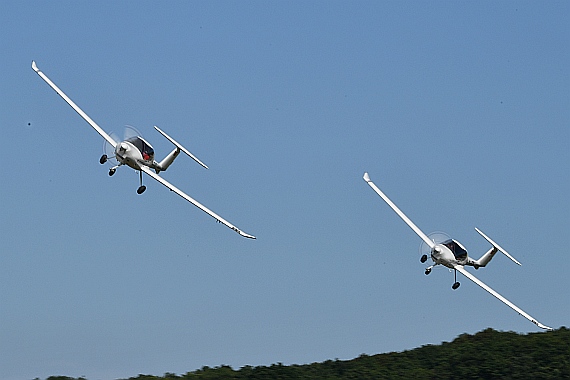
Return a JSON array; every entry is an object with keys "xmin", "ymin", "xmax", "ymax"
[{"xmin": 47, "ymin": 327, "xmax": 570, "ymax": 380}]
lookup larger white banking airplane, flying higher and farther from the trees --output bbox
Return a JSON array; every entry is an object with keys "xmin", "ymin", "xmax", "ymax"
[{"xmin": 32, "ymin": 61, "xmax": 255, "ymax": 239}]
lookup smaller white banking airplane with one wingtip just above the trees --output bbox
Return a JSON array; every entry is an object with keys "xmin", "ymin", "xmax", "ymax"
[{"xmin": 363, "ymin": 173, "xmax": 552, "ymax": 330}]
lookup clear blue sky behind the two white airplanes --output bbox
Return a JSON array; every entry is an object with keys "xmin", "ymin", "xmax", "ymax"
[{"xmin": 0, "ymin": 1, "xmax": 570, "ymax": 380}]
